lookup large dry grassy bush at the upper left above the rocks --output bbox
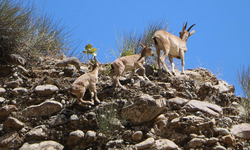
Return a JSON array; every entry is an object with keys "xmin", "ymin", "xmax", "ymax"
[{"xmin": 0, "ymin": 0, "xmax": 73, "ymax": 65}]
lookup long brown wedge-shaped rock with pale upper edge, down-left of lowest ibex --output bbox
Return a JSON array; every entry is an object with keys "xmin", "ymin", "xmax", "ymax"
[{"xmin": 22, "ymin": 100, "xmax": 63, "ymax": 117}]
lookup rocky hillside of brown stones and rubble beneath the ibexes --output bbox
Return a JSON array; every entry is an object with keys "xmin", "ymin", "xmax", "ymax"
[{"xmin": 0, "ymin": 55, "xmax": 250, "ymax": 150}]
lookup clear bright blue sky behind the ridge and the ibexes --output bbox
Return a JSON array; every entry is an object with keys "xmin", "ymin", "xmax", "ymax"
[{"xmin": 24, "ymin": 0, "xmax": 250, "ymax": 96}]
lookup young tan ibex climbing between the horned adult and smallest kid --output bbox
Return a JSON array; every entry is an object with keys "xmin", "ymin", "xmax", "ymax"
[{"xmin": 111, "ymin": 43, "xmax": 154, "ymax": 89}]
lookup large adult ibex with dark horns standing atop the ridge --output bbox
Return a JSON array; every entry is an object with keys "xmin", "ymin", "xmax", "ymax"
[{"xmin": 152, "ymin": 23, "xmax": 195, "ymax": 75}]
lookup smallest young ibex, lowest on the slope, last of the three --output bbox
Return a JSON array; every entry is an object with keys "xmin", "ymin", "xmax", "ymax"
[{"xmin": 71, "ymin": 57, "xmax": 104, "ymax": 106}]
